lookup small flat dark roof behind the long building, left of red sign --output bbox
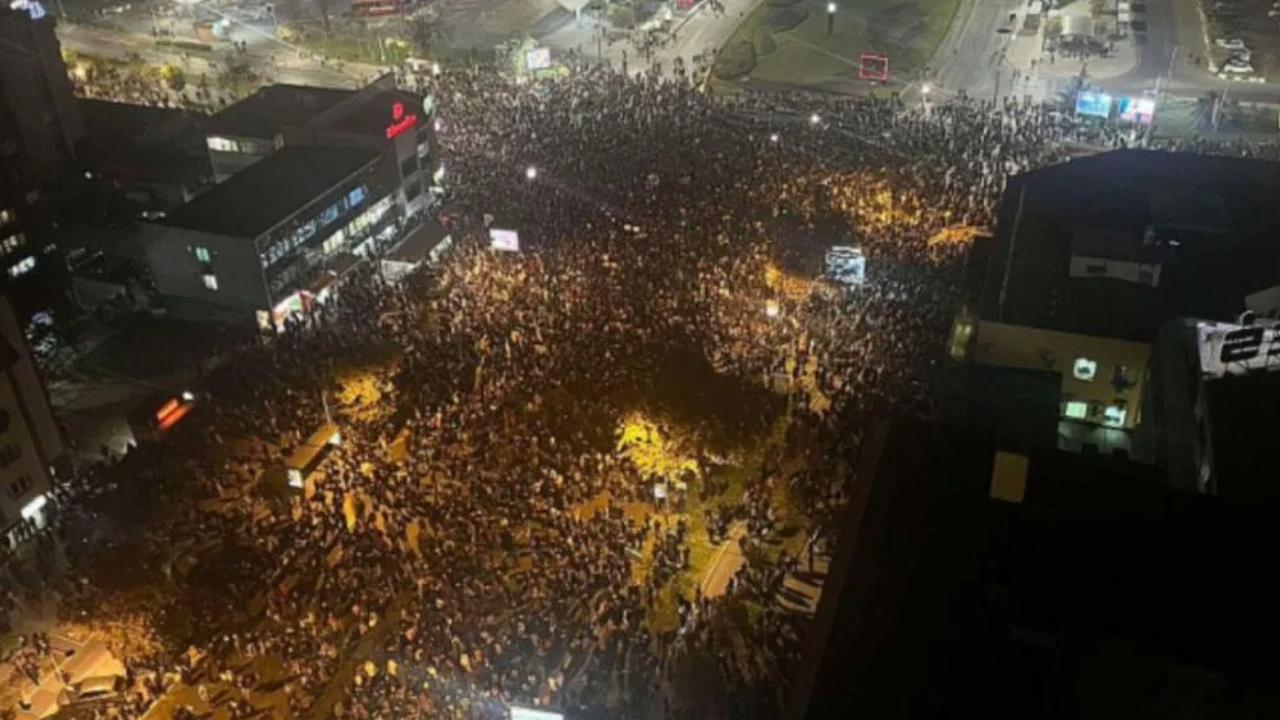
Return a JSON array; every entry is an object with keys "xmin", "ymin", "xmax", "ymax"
[{"xmin": 207, "ymin": 85, "xmax": 356, "ymax": 140}]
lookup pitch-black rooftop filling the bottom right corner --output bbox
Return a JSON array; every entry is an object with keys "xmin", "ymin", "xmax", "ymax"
[{"xmin": 783, "ymin": 423, "xmax": 1280, "ymax": 720}]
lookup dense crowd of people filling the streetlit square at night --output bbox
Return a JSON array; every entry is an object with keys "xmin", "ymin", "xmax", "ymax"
[{"xmin": 7, "ymin": 53, "xmax": 1280, "ymax": 720}]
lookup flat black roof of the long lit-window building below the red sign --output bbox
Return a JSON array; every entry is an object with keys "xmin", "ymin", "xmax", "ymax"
[{"xmin": 160, "ymin": 146, "xmax": 381, "ymax": 238}]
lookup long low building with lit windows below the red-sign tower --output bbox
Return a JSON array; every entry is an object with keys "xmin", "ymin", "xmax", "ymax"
[{"xmin": 142, "ymin": 146, "xmax": 401, "ymax": 329}]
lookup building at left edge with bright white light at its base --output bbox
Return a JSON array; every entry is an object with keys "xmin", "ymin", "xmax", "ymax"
[{"xmin": 0, "ymin": 292, "xmax": 64, "ymax": 551}]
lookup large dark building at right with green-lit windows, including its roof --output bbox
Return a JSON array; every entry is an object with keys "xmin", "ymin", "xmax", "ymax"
[{"xmin": 947, "ymin": 151, "xmax": 1280, "ymax": 500}]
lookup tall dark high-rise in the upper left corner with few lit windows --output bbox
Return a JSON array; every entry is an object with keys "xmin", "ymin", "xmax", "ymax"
[{"xmin": 0, "ymin": 0, "xmax": 84, "ymax": 316}]
